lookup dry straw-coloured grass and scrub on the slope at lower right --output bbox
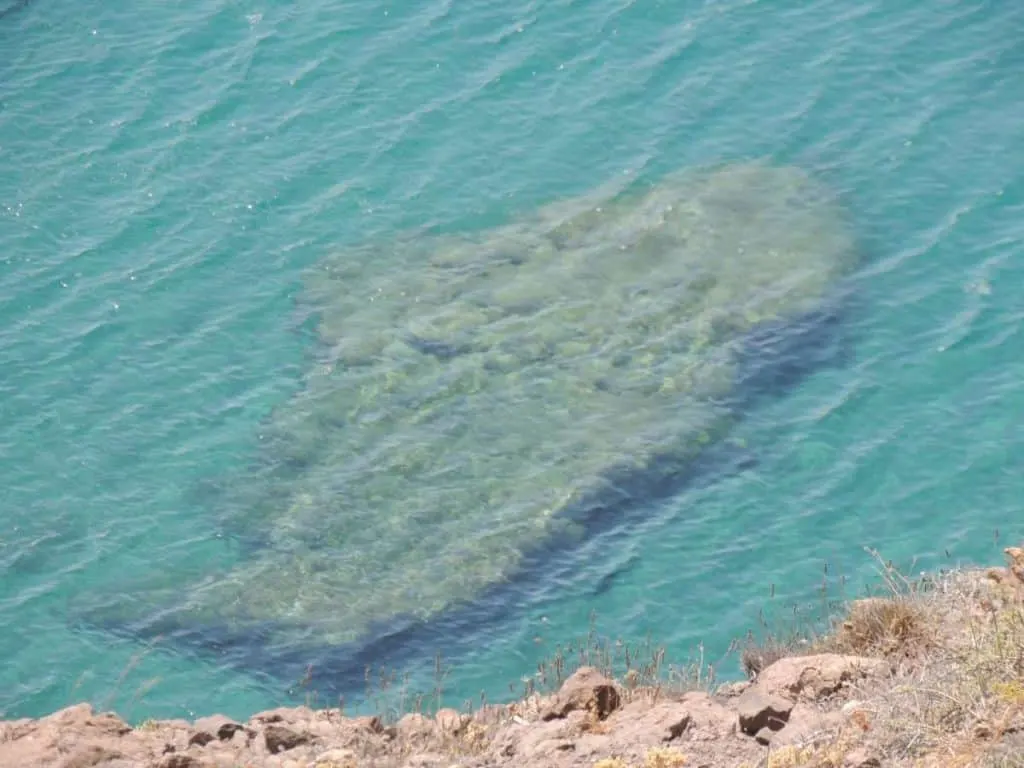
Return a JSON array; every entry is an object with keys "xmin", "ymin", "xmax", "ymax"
[{"xmin": 744, "ymin": 547, "xmax": 1024, "ymax": 768}]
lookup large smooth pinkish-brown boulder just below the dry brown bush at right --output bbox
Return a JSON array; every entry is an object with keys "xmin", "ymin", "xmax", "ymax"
[{"xmin": 757, "ymin": 653, "xmax": 888, "ymax": 700}]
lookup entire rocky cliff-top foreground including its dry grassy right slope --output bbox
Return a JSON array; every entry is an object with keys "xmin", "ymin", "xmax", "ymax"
[{"xmin": 0, "ymin": 548, "xmax": 1024, "ymax": 768}]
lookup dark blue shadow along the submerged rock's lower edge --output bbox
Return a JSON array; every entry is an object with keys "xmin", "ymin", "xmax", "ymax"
[{"xmin": 81, "ymin": 280, "xmax": 864, "ymax": 701}]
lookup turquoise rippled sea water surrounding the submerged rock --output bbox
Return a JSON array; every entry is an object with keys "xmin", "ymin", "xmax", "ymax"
[{"xmin": 0, "ymin": 0, "xmax": 1024, "ymax": 720}]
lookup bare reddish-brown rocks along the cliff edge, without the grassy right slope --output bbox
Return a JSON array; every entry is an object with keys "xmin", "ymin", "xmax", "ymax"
[{"xmin": 0, "ymin": 656, "xmax": 877, "ymax": 768}]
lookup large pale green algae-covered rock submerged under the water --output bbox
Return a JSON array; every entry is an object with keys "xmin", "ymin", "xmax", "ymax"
[{"xmin": 134, "ymin": 163, "xmax": 854, "ymax": 644}]
